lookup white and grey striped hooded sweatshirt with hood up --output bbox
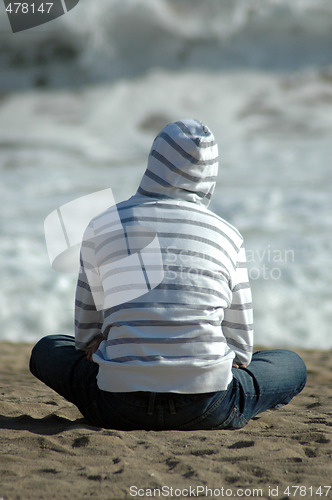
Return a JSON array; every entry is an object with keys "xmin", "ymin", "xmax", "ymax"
[{"xmin": 75, "ymin": 120, "xmax": 253, "ymax": 393}]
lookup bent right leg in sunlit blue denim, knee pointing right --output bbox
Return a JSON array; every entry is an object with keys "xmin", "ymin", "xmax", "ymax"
[{"xmin": 224, "ymin": 349, "xmax": 307, "ymax": 428}]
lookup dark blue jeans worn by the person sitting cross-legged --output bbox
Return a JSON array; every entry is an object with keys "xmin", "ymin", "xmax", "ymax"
[{"xmin": 30, "ymin": 335, "xmax": 307, "ymax": 430}]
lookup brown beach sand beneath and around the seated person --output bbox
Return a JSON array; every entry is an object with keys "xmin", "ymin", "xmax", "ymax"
[{"xmin": 0, "ymin": 342, "xmax": 332, "ymax": 500}]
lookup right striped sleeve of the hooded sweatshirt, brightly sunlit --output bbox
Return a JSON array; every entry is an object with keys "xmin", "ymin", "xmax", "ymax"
[{"xmin": 222, "ymin": 246, "xmax": 253, "ymax": 365}]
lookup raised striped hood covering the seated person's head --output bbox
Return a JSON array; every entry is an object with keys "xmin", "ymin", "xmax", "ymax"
[{"xmin": 138, "ymin": 120, "xmax": 218, "ymax": 207}]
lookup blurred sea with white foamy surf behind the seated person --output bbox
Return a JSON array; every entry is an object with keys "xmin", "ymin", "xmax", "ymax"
[{"xmin": 0, "ymin": 0, "xmax": 332, "ymax": 349}]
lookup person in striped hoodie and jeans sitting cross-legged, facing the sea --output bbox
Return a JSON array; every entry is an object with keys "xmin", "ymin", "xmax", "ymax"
[{"xmin": 30, "ymin": 119, "xmax": 306, "ymax": 430}]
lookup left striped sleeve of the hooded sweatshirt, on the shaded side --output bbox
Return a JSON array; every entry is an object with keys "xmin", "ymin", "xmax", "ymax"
[{"xmin": 75, "ymin": 228, "xmax": 103, "ymax": 350}]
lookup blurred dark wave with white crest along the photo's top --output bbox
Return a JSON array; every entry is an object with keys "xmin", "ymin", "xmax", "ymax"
[{"xmin": 0, "ymin": 0, "xmax": 332, "ymax": 89}]
